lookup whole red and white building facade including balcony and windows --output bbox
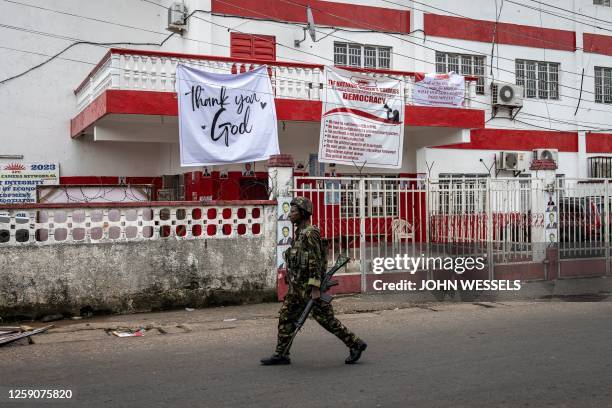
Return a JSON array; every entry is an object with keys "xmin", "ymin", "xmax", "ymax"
[{"xmin": 0, "ymin": 0, "xmax": 612, "ymax": 200}]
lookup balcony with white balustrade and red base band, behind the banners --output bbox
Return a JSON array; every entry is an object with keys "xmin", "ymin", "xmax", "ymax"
[{"xmin": 70, "ymin": 49, "xmax": 484, "ymax": 141}]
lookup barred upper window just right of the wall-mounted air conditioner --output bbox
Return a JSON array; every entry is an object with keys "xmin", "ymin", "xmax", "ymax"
[{"xmin": 516, "ymin": 60, "xmax": 559, "ymax": 99}]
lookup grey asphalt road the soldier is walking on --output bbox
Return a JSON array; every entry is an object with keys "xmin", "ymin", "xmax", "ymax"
[{"xmin": 0, "ymin": 302, "xmax": 612, "ymax": 408}]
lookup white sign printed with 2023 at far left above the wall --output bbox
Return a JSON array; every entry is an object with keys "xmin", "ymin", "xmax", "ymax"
[{"xmin": 0, "ymin": 162, "xmax": 59, "ymax": 204}]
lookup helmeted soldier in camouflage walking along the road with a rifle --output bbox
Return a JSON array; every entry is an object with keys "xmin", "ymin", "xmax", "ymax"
[{"xmin": 261, "ymin": 197, "xmax": 367, "ymax": 365}]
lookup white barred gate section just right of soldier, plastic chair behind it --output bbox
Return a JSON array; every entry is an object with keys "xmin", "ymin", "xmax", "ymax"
[{"xmin": 293, "ymin": 177, "xmax": 427, "ymax": 291}]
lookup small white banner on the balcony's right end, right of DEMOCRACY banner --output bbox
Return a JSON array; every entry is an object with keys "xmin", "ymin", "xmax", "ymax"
[{"xmin": 412, "ymin": 72, "xmax": 465, "ymax": 107}]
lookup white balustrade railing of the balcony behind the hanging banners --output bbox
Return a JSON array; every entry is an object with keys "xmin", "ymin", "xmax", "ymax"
[{"xmin": 74, "ymin": 49, "xmax": 477, "ymax": 112}]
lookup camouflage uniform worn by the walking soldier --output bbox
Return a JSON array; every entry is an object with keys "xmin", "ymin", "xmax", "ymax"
[{"xmin": 276, "ymin": 225, "xmax": 361, "ymax": 355}]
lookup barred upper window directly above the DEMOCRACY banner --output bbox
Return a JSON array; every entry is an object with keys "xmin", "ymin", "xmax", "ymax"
[{"xmin": 334, "ymin": 42, "xmax": 391, "ymax": 69}]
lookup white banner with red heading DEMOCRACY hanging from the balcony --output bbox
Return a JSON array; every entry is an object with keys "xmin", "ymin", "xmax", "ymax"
[{"xmin": 319, "ymin": 67, "xmax": 404, "ymax": 169}]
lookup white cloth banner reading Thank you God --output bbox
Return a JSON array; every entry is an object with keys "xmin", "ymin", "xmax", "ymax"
[{"xmin": 176, "ymin": 64, "xmax": 279, "ymax": 166}]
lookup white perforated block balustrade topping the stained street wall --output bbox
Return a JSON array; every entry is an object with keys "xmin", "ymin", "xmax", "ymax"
[{"xmin": 0, "ymin": 203, "xmax": 268, "ymax": 248}]
